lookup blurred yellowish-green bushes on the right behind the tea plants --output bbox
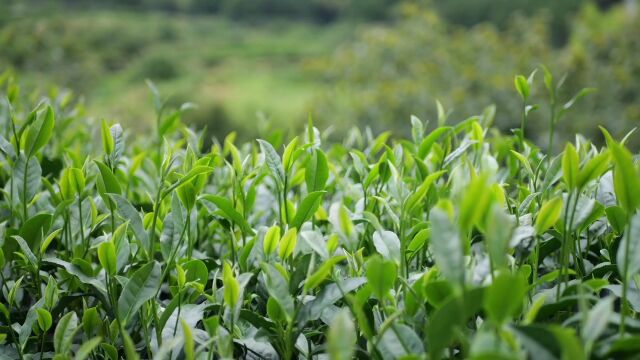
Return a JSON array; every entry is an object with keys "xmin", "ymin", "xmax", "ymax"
[{"xmin": 314, "ymin": 2, "xmax": 640, "ymax": 147}]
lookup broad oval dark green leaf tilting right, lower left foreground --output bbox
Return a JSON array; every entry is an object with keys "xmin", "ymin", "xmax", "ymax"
[{"xmin": 118, "ymin": 261, "xmax": 160, "ymax": 323}]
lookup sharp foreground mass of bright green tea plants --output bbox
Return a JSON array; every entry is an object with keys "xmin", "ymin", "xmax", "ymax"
[{"xmin": 0, "ymin": 68, "xmax": 640, "ymax": 360}]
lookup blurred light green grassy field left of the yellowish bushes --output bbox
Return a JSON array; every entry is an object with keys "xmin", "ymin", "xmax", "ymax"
[{"xmin": 0, "ymin": 10, "xmax": 357, "ymax": 138}]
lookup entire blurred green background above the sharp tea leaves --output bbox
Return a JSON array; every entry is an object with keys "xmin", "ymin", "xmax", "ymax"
[{"xmin": 0, "ymin": 0, "xmax": 640, "ymax": 149}]
